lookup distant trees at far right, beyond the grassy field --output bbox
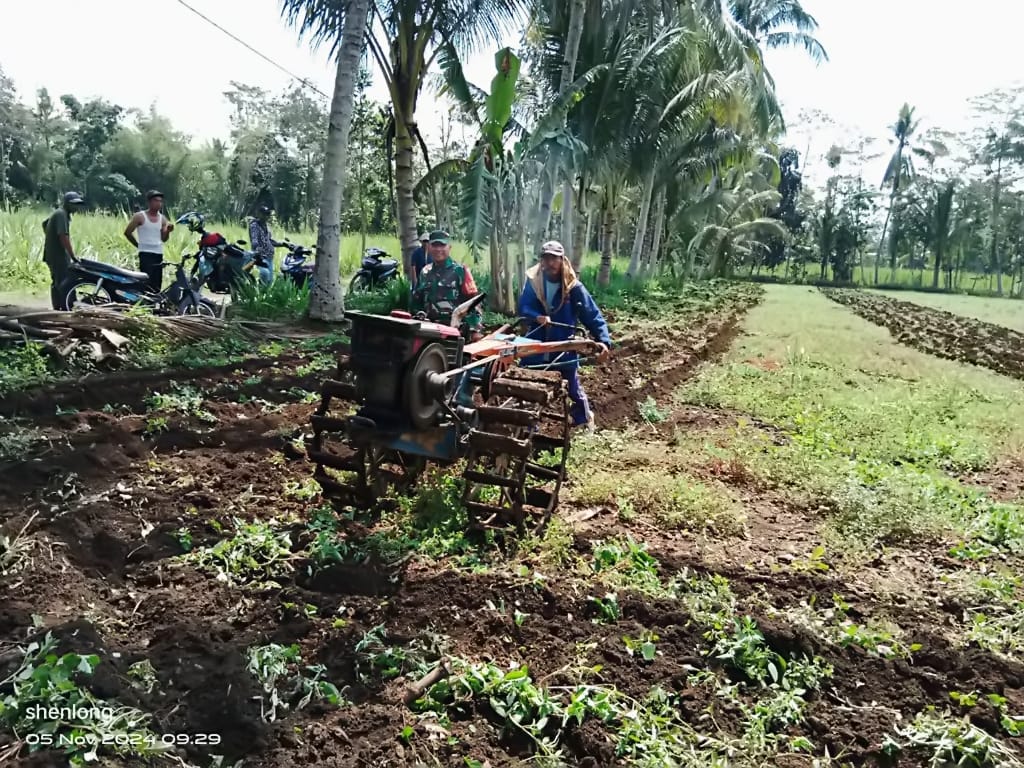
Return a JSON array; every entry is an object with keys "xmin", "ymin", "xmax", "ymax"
[{"xmin": 790, "ymin": 88, "xmax": 1024, "ymax": 297}]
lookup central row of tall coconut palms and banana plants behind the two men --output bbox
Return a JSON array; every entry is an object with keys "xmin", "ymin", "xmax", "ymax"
[{"xmin": 281, "ymin": 0, "xmax": 826, "ymax": 317}]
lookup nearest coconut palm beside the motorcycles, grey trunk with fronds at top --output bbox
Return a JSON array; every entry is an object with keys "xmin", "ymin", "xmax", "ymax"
[{"xmin": 282, "ymin": 0, "xmax": 370, "ymax": 321}]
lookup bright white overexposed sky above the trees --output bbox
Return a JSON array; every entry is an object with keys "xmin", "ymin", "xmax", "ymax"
[{"xmin": 0, "ymin": 0, "xmax": 1024, "ymax": 192}]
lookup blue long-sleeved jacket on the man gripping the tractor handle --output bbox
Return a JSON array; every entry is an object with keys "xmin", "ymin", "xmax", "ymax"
[{"xmin": 518, "ymin": 259, "xmax": 611, "ymax": 371}]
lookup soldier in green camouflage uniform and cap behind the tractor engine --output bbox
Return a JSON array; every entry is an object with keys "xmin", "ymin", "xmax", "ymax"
[{"xmin": 410, "ymin": 229, "xmax": 483, "ymax": 341}]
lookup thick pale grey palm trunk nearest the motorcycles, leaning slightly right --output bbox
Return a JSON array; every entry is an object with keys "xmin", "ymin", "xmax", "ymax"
[{"xmin": 309, "ymin": 0, "xmax": 370, "ymax": 322}]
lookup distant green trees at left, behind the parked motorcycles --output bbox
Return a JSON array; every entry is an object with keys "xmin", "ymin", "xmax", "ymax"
[{"xmin": 0, "ymin": 70, "xmax": 394, "ymax": 233}]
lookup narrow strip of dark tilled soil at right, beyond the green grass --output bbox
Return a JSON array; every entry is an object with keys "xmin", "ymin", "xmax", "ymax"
[{"xmin": 820, "ymin": 288, "xmax": 1024, "ymax": 379}]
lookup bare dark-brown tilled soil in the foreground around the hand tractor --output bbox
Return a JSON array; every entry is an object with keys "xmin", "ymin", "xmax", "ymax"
[{"xmin": 0, "ymin": 290, "xmax": 1024, "ymax": 768}]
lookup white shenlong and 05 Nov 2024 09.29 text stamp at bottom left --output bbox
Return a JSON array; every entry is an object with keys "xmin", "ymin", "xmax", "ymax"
[{"xmin": 24, "ymin": 705, "xmax": 220, "ymax": 751}]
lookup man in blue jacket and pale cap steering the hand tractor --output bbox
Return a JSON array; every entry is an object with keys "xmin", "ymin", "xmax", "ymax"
[{"xmin": 519, "ymin": 241, "xmax": 611, "ymax": 430}]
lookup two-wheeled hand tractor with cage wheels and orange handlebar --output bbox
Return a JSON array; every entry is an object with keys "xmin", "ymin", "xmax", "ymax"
[{"xmin": 306, "ymin": 294, "xmax": 599, "ymax": 531}]
